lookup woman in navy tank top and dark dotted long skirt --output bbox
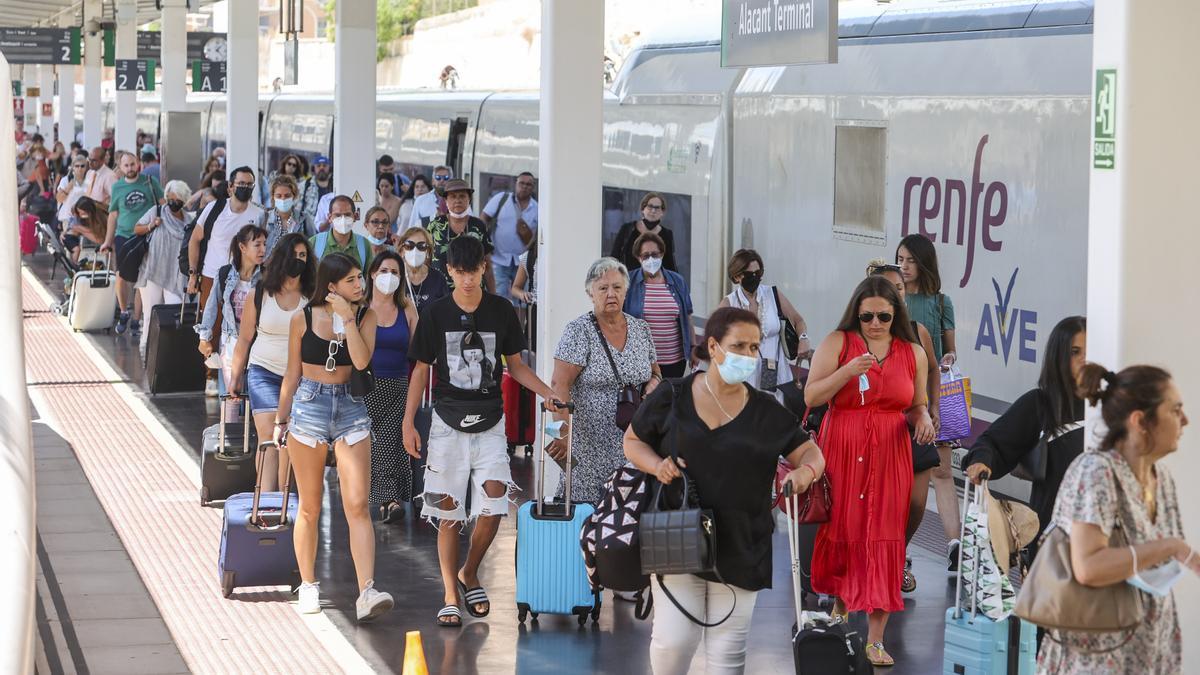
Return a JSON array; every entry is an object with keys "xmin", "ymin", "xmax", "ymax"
[{"xmin": 366, "ymin": 251, "xmax": 416, "ymax": 522}]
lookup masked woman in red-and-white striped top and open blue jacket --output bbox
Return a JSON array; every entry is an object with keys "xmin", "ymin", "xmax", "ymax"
[{"xmin": 625, "ymin": 232, "xmax": 691, "ymax": 377}]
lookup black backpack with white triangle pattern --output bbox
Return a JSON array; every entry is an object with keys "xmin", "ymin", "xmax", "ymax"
[{"xmin": 580, "ymin": 462, "xmax": 654, "ymax": 619}]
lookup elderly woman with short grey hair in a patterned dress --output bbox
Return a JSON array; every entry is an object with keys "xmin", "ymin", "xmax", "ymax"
[{"xmin": 548, "ymin": 258, "xmax": 662, "ymax": 502}]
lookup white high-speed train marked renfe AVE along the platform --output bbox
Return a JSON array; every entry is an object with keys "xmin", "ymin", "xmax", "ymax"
[{"xmin": 87, "ymin": 0, "xmax": 1093, "ymax": 491}]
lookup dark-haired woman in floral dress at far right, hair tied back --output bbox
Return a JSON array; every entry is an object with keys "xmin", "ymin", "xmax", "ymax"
[{"xmin": 1038, "ymin": 363, "xmax": 1200, "ymax": 675}]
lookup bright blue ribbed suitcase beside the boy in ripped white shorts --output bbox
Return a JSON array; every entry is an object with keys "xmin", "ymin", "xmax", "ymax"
[{"xmin": 517, "ymin": 404, "xmax": 600, "ymax": 626}]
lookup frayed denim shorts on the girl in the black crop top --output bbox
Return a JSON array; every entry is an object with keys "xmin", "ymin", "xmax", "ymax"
[{"xmin": 288, "ymin": 377, "xmax": 371, "ymax": 447}]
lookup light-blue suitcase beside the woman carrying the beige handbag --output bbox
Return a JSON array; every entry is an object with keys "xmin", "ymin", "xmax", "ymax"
[{"xmin": 942, "ymin": 480, "xmax": 1038, "ymax": 675}]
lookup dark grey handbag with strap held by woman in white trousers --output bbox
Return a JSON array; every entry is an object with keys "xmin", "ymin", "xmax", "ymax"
[{"xmin": 637, "ymin": 383, "xmax": 738, "ymax": 628}]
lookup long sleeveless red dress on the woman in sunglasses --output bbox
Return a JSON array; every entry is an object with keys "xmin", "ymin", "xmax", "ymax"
[{"xmin": 812, "ymin": 331, "xmax": 917, "ymax": 611}]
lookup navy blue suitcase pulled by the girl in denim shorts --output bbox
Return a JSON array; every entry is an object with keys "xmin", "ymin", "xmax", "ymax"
[{"xmin": 217, "ymin": 442, "xmax": 300, "ymax": 598}]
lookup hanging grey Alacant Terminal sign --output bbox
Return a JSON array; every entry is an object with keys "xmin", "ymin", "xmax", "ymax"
[{"xmin": 721, "ymin": 0, "xmax": 838, "ymax": 67}]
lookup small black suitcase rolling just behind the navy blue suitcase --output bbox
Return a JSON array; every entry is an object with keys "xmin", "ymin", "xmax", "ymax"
[{"xmin": 200, "ymin": 396, "xmax": 257, "ymax": 506}]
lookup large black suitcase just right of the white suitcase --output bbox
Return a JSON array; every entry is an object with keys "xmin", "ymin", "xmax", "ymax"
[{"xmin": 146, "ymin": 298, "xmax": 208, "ymax": 394}]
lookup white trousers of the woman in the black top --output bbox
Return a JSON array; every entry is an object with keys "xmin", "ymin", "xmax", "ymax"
[{"xmin": 650, "ymin": 574, "xmax": 758, "ymax": 675}]
